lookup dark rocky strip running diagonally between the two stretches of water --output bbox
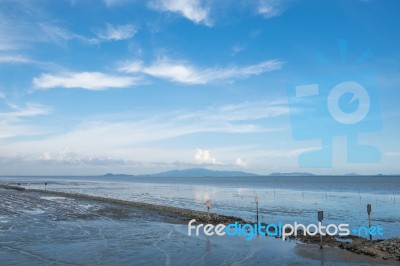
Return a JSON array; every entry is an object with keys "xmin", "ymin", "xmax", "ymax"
[{"xmin": 0, "ymin": 184, "xmax": 400, "ymax": 261}]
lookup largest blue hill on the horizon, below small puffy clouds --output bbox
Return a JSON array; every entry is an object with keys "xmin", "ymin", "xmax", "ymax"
[{"xmin": 150, "ymin": 168, "xmax": 257, "ymax": 177}]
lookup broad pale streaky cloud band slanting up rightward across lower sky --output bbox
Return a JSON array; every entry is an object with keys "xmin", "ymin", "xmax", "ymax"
[{"xmin": 3, "ymin": 100, "xmax": 288, "ymax": 156}]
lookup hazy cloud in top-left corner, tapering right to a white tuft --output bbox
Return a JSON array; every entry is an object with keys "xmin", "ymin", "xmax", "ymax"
[{"xmin": 0, "ymin": 0, "xmax": 136, "ymax": 51}]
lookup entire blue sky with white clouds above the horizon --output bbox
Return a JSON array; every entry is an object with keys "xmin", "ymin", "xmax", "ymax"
[{"xmin": 0, "ymin": 0, "xmax": 400, "ymax": 175}]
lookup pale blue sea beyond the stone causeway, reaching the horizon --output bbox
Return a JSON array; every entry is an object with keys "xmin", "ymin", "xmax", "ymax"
[{"xmin": 0, "ymin": 176, "xmax": 400, "ymax": 238}]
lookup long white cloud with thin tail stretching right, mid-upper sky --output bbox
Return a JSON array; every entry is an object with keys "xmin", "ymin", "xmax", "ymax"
[{"xmin": 119, "ymin": 58, "xmax": 283, "ymax": 84}]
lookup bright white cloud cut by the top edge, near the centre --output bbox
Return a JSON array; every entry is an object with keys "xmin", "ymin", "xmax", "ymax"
[{"xmin": 150, "ymin": 0, "xmax": 212, "ymax": 26}]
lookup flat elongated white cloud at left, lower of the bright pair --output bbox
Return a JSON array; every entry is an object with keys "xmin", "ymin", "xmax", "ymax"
[{"xmin": 33, "ymin": 72, "xmax": 138, "ymax": 91}]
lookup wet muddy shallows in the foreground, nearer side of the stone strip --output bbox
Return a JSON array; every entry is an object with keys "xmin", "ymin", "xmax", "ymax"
[{"xmin": 0, "ymin": 188, "xmax": 394, "ymax": 265}]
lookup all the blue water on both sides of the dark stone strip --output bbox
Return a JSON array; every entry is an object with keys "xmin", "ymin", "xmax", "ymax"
[{"xmin": 0, "ymin": 175, "xmax": 400, "ymax": 266}]
